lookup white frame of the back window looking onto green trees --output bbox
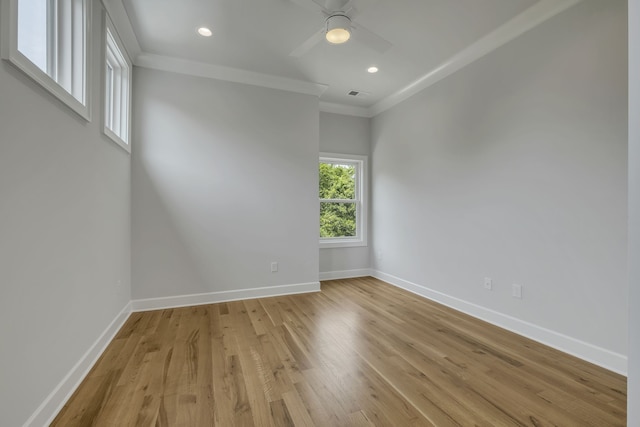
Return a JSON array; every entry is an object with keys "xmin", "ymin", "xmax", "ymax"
[{"xmin": 318, "ymin": 153, "xmax": 369, "ymax": 249}]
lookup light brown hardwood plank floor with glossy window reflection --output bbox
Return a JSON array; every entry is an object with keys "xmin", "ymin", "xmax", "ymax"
[{"xmin": 52, "ymin": 278, "xmax": 626, "ymax": 427}]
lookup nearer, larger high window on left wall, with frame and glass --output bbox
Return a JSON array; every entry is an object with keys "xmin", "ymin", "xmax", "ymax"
[{"xmin": 2, "ymin": 0, "xmax": 91, "ymax": 120}]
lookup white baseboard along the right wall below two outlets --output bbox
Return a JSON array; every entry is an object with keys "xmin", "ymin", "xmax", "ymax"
[{"xmin": 371, "ymin": 270, "xmax": 627, "ymax": 376}]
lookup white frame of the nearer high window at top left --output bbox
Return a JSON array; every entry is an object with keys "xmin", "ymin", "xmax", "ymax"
[{"xmin": 0, "ymin": 0, "xmax": 92, "ymax": 121}]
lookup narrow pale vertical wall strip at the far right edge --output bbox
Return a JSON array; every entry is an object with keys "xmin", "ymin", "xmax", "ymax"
[{"xmin": 627, "ymin": 0, "xmax": 640, "ymax": 426}]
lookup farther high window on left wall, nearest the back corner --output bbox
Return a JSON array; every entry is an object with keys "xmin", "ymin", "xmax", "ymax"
[{"xmin": 102, "ymin": 13, "xmax": 133, "ymax": 153}]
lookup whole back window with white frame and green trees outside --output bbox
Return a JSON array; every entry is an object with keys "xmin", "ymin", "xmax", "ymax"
[{"xmin": 319, "ymin": 153, "xmax": 367, "ymax": 248}]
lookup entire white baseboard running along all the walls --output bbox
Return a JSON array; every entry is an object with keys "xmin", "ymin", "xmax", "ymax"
[{"xmin": 23, "ymin": 269, "xmax": 627, "ymax": 427}]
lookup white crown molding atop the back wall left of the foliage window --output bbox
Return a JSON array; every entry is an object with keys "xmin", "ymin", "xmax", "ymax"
[{"xmin": 134, "ymin": 53, "xmax": 328, "ymax": 96}]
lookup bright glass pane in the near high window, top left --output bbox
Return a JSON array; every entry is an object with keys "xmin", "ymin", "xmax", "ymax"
[{"xmin": 18, "ymin": 0, "xmax": 48, "ymax": 73}]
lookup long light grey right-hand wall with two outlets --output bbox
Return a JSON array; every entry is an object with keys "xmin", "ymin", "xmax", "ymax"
[{"xmin": 372, "ymin": 0, "xmax": 628, "ymax": 371}]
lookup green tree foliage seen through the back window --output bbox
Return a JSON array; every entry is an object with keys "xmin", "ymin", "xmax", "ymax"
[{"xmin": 320, "ymin": 163, "xmax": 356, "ymax": 237}]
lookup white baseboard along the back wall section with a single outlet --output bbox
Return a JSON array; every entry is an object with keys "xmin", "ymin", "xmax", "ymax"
[{"xmin": 131, "ymin": 282, "xmax": 320, "ymax": 311}]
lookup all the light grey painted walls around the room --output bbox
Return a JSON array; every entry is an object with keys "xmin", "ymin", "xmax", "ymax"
[{"xmin": 0, "ymin": 0, "xmax": 640, "ymax": 425}]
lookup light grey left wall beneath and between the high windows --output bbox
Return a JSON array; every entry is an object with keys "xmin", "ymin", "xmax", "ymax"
[{"xmin": 0, "ymin": 3, "xmax": 131, "ymax": 426}]
